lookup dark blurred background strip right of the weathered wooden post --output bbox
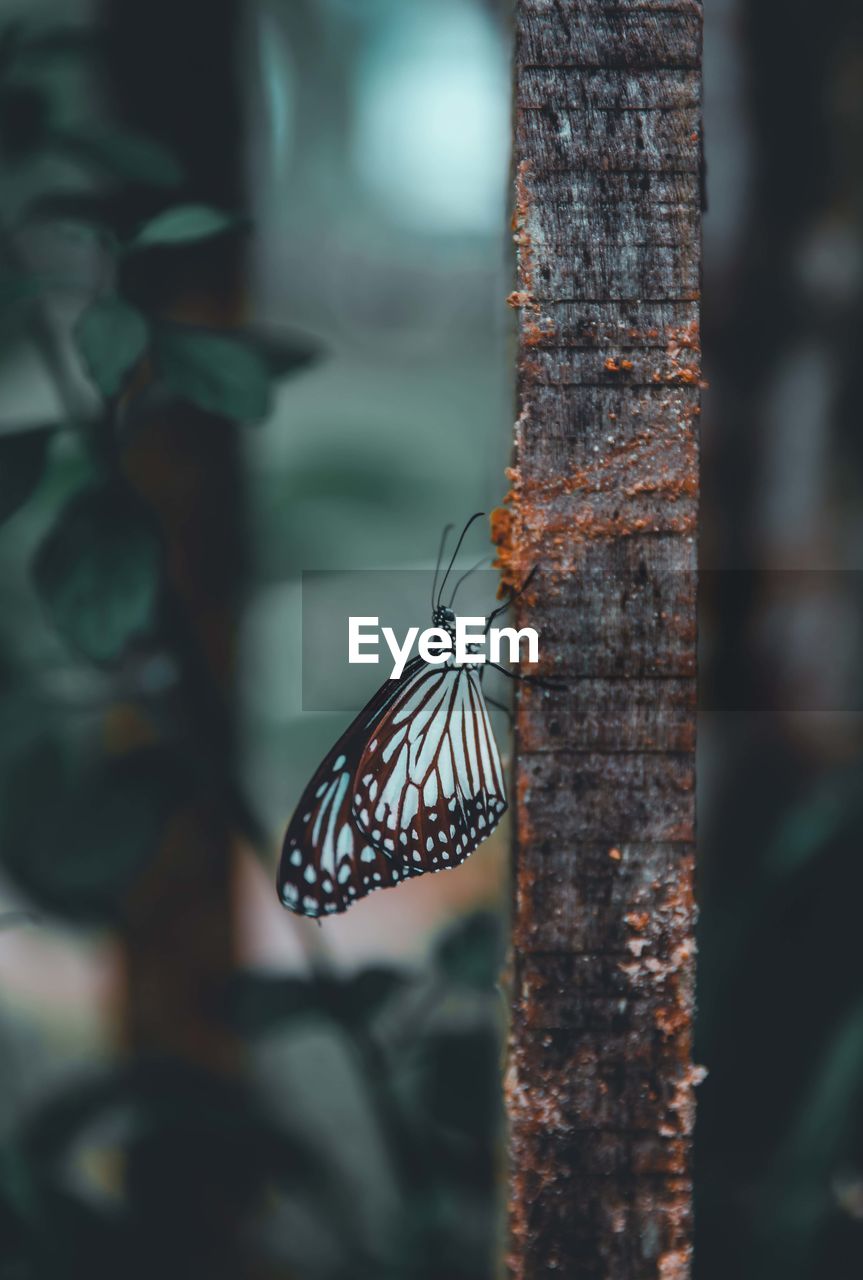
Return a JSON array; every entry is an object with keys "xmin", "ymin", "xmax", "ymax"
[{"xmin": 697, "ymin": 0, "xmax": 863, "ymax": 1280}]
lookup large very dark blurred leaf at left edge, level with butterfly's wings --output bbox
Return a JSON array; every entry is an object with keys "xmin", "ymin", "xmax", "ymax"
[{"xmin": 0, "ymin": 739, "xmax": 184, "ymax": 920}]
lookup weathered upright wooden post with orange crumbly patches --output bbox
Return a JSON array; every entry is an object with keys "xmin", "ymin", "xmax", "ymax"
[{"xmin": 496, "ymin": 0, "xmax": 702, "ymax": 1280}]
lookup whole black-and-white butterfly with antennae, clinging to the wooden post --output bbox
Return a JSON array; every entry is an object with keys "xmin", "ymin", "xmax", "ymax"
[{"xmin": 277, "ymin": 512, "xmax": 526, "ymax": 918}]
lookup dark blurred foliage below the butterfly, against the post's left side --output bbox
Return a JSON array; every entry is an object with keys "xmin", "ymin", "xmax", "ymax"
[{"xmin": 218, "ymin": 913, "xmax": 502, "ymax": 1280}]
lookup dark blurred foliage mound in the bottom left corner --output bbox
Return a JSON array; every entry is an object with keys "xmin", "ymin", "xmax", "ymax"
[{"xmin": 0, "ymin": 1059, "xmax": 318, "ymax": 1280}]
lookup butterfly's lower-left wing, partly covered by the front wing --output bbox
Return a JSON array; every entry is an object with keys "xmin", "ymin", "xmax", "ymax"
[{"xmin": 277, "ymin": 658, "xmax": 425, "ymax": 916}]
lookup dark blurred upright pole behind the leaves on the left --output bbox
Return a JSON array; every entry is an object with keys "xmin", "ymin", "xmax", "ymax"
[{"xmin": 102, "ymin": 0, "xmax": 248, "ymax": 1280}]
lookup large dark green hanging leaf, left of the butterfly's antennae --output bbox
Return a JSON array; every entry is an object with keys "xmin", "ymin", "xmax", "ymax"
[{"xmin": 33, "ymin": 489, "xmax": 160, "ymax": 662}]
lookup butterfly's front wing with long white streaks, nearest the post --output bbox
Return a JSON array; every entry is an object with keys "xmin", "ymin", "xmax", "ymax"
[{"xmin": 353, "ymin": 666, "xmax": 507, "ymax": 878}]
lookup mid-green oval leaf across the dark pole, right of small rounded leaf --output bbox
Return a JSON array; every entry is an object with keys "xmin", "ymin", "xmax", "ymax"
[{"xmin": 155, "ymin": 328, "xmax": 270, "ymax": 422}]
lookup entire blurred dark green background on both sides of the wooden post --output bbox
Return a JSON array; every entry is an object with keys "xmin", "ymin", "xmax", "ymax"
[{"xmin": 0, "ymin": 0, "xmax": 863, "ymax": 1280}]
